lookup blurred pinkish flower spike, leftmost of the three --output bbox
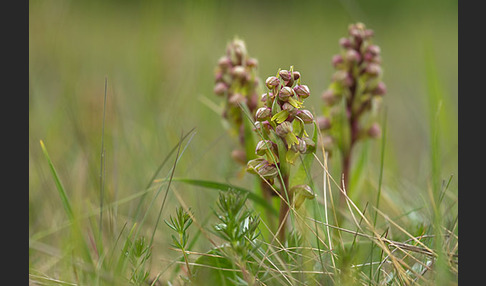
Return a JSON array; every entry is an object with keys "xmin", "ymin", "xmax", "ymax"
[{"xmin": 214, "ymin": 38, "xmax": 261, "ymax": 162}]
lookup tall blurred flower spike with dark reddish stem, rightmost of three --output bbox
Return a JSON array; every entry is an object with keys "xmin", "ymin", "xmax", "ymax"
[{"xmin": 316, "ymin": 23, "xmax": 386, "ymax": 197}]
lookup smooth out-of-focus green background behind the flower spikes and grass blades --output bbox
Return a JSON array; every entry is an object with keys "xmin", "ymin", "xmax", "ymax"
[{"xmin": 29, "ymin": 0, "xmax": 458, "ymax": 282}]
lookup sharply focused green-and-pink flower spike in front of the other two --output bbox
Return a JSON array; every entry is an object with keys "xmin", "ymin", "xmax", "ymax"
[{"xmin": 247, "ymin": 67, "xmax": 315, "ymax": 241}]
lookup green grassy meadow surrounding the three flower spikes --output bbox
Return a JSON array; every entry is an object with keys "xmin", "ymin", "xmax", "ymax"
[{"xmin": 29, "ymin": 0, "xmax": 459, "ymax": 285}]
